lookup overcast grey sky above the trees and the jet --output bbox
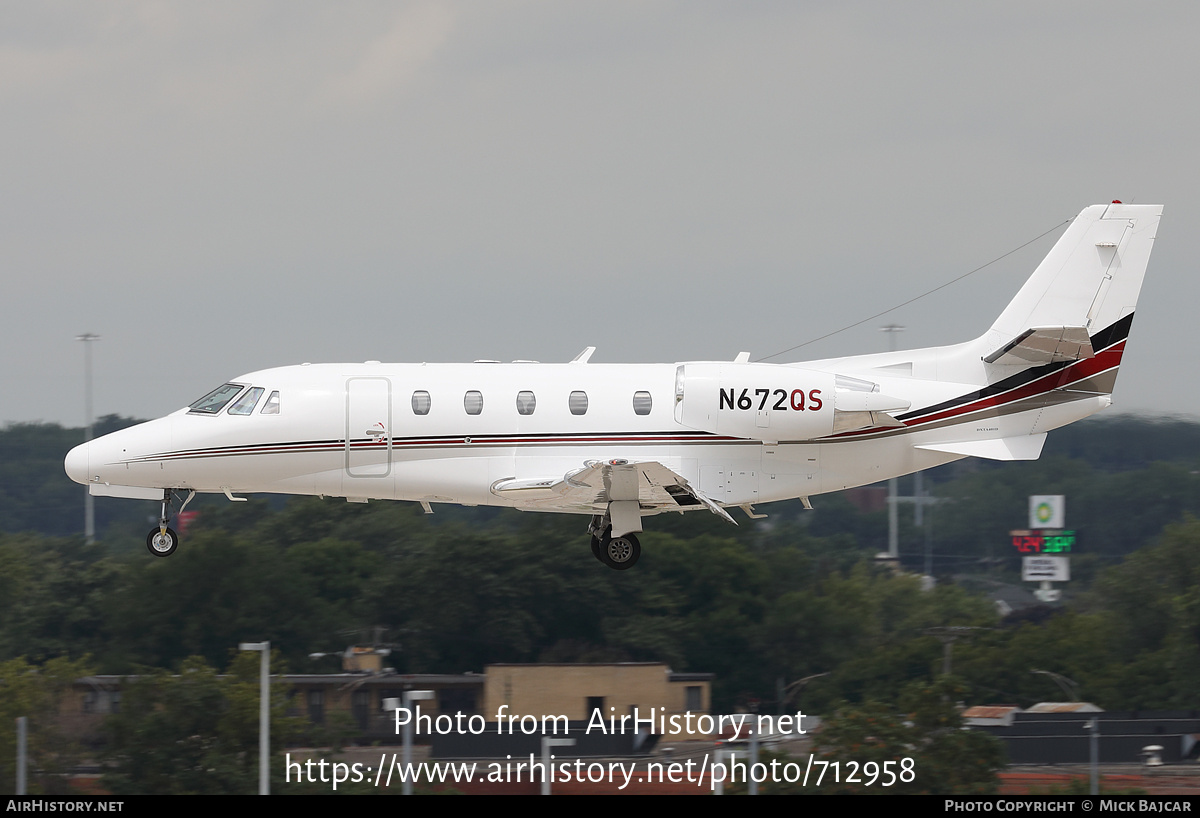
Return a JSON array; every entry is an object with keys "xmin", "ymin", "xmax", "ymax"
[{"xmin": 0, "ymin": 0, "xmax": 1200, "ymax": 425}]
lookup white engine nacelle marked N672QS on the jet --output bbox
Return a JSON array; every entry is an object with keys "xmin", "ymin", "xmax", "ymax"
[{"xmin": 674, "ymin": 362, "xmax": 835, "ymax": 441}]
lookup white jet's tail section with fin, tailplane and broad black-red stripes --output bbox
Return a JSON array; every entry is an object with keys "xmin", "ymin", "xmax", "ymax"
[{"xmin": 876, "ymin": 202, "xmax": 1163, "ymax": 461}]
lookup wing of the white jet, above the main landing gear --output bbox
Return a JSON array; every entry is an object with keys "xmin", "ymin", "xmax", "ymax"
[{"xmin": 492, "ymin": 458, "xmax": 737, "ymax": 524}]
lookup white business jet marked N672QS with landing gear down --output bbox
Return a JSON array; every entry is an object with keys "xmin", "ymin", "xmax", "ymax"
[{"xmin": 66, "ymin": 202, "xmax": 1162, "ymax": 570}]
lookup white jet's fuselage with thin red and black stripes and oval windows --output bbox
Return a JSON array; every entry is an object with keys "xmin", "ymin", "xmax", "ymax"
[{"xmin": 68, "ymin": 350, "xmax": 1100, "ymax": 513}]
